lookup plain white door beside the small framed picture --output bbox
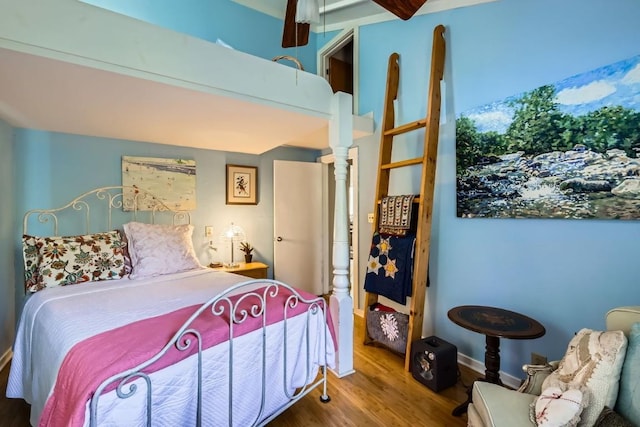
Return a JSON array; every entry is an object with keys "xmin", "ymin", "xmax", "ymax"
[{"xmin": 273, "ymin": 160, "xmax": 323, "ymax": 295}]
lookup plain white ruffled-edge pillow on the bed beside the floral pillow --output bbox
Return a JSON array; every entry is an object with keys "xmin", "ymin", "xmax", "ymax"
[{"xmin": 123, "ymin": 222, "xmax": 202, "ymax": 279}]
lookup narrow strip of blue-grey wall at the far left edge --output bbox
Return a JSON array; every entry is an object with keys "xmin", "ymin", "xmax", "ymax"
[{"xmin": 0, "ymin": 120, "xmax": 16, "ymax": 368}]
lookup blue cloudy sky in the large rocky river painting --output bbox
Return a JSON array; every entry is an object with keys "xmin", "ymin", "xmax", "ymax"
[{"xmin": 461, "ymin": 55, "xmax": 640, "ymax": 133}]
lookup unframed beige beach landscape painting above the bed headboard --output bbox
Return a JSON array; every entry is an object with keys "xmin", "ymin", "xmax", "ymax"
[{"xmin": 122, "ymin": 156, "xmax": 196, "ymax": 211}]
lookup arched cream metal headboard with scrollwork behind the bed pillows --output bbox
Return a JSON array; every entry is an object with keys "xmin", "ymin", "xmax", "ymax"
[{"xmin": 22, "ymin": 186, "xmax": 191, "ymax": 236}]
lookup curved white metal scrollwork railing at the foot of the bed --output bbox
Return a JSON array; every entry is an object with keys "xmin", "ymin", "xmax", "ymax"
[{"xmin": 89, "ymin": 279, "xmax": 332, "ymax": 427}]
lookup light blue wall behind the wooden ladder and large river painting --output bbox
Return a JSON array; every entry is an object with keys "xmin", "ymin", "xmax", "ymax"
[{"xmin": 357, "ymin": 0, "xmax": 640, "ymax": 376}]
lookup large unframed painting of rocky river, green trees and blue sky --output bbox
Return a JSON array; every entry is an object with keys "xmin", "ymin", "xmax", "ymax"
[{"xmin": 456, "ymin": 55, "xmax": 640, "ymax": 219}]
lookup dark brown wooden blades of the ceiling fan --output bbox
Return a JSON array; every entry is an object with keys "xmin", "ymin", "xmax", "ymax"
[{"xmin": 282, "ymin": 0, "xmax": 427, "ymax": 47}]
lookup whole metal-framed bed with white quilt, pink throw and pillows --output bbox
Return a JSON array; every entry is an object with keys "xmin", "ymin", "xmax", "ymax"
[{"xmin": 7, "ymin": 186, "xmax": 336, "ymax": 426}]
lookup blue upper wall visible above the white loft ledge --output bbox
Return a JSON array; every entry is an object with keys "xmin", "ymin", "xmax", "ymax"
[{"xmin": 82, "ymin": 0, "xmax": 316, "ymax": 70}]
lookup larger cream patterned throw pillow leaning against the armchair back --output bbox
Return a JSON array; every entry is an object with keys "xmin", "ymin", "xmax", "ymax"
[{"xmin": 542, "ymin": 329, "xmax": 627, "ymax": 426}]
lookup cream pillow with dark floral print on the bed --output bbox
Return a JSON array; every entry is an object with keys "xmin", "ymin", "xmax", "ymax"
[{"xmin": 28, "ymin": 231, "xmax": 125, "ymax": 292}]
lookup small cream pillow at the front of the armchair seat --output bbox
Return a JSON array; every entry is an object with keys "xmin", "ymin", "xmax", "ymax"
[{"xmin": 531, "ymin": 386, "xmax": 588, "ymax": 427}]
